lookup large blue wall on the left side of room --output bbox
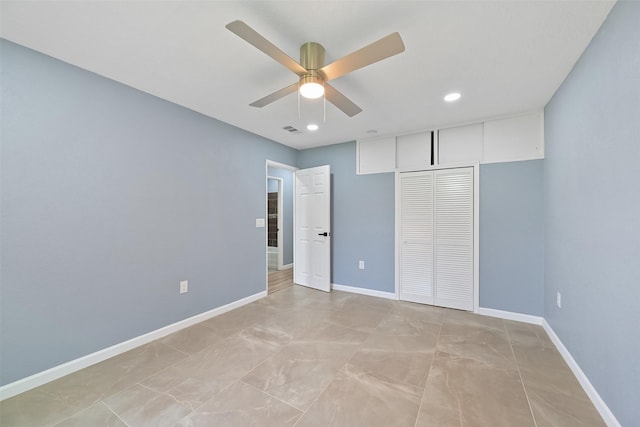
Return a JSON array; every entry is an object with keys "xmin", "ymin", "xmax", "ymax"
[{"xmin": 0, "ymin": 41, "xmax": 297, "ymax": 384}]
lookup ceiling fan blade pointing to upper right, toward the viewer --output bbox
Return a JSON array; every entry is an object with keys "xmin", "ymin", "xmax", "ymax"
[{"xmin": 320, "ymin": 33, "xmax": 404, "ymax": 80}]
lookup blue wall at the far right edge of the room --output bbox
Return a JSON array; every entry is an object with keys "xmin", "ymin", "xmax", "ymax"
[{"xmin": 545, "ymin": 1, "xmax": 640, "ymax": 426}]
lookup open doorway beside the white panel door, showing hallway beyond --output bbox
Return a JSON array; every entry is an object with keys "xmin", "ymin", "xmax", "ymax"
[{"xmin": 265, "ymin": 160, "xmax": 296, "ymax": 293}]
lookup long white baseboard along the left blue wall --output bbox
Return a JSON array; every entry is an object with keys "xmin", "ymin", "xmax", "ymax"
[{"xmin": 0, "ymin": 291, "xmax": 267, "ymax": 401}]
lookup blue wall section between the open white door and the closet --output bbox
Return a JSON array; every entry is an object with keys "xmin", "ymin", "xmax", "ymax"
[{"xmin": 298, "ymin": 142, "xmax": 395, "ymax": 292}]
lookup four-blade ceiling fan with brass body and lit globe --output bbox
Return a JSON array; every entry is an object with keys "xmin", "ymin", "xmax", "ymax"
[{"xmin": 226, "ymin": 21, "xmax": 404, "ymax": 117}]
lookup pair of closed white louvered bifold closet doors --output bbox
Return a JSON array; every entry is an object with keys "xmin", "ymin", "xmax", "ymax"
[{"xmin": 398, "ymin": 167, "xmax": 475, "ymax": 310}]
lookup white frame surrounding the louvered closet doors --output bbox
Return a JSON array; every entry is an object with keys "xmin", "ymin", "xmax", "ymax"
[{"xmin": 395, "ymin": 162, "xmax": 480, "ymax": 313}]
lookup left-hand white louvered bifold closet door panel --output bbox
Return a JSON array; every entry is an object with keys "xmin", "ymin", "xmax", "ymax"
[{"xmin": 399, "ymin": 172, "xmax": 434, "ymax": 304}]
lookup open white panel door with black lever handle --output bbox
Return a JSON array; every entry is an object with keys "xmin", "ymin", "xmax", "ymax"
[{"xmin": 293, "ymin": 165, "xmax": 331, "ymax": 292}]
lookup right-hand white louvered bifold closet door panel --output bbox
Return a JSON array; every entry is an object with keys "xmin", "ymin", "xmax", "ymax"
[{"xmin": 433, "ymin": 168, "xmax": 474, "ymax": 310}]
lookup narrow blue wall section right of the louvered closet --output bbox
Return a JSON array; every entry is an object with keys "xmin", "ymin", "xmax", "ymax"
[{"xmin": 480, "ymin": 160, "xmax": 544, "ymax": 316}]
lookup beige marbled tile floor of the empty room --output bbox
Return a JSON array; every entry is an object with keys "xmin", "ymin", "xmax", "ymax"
[{"xmin": 0, "ymin": 286, "xmax": 604, "ymax": 427}]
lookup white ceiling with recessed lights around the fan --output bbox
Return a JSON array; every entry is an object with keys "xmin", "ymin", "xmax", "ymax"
[{"xmin": 0, "ymin": 0, "xmax": 614, "ymax": 149}]
